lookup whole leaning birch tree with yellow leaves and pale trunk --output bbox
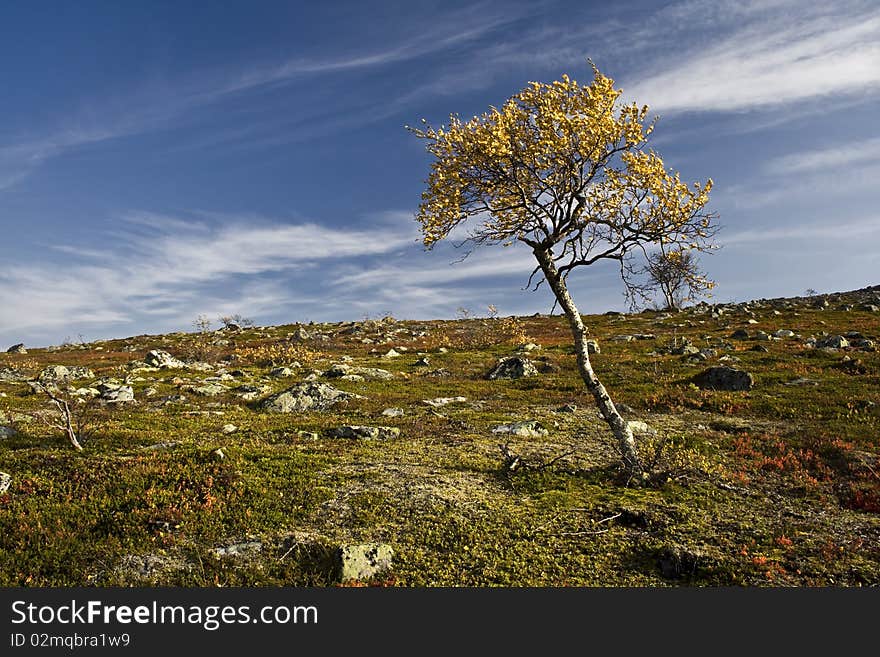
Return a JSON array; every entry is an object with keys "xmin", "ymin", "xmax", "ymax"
[{"xmin": 409, "ymin": 66, "xmax": 714, "ymax": 476}]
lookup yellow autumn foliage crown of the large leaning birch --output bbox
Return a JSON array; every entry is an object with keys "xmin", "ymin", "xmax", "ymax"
[{"xmin": 409, "ymin": 67, "xmax": 712, "ymax": 247}]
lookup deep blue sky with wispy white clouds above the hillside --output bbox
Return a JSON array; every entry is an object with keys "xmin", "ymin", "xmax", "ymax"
[{"xmin": 0, "ymin": 0, "xmax": 880, "ymax": 348}]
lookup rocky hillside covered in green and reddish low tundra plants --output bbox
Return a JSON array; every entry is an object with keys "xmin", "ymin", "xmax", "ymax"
[{"xmin": 0, "ymin": 286, "xmax": 880, "ymax": 586}]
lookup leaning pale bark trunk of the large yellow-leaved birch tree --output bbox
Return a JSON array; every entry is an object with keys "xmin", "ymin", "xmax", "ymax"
[{"xmin": 533, "ymin": 249, "xmax": 642, "ymax": 476}]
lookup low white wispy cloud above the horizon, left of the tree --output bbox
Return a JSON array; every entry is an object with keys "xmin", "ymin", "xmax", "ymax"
[{"xmin": 0, "ymin": 213, "xmax": 415, "ymax": 340}]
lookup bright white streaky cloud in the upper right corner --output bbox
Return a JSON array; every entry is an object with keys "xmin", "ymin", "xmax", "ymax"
[{"xmin": 626, "ymin": 3, "xmax": 880, "ymax": 114}]
